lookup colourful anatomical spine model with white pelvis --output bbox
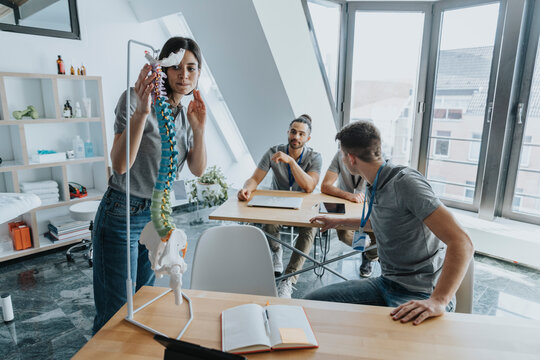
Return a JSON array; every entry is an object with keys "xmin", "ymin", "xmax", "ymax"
[{"xmin": 140, "ymin": 49, "xmax": 187, "ymax": 305}]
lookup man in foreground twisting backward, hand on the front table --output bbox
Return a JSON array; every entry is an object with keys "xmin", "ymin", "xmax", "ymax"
[{"xmin": 306, "ymin": 121, "xmax": 474, "ymax": 325}]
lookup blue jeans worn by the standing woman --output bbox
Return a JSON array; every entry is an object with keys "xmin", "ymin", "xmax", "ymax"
[{"xmin": 92, "ymin": 188, "xmax": 155, "ymax": 334}]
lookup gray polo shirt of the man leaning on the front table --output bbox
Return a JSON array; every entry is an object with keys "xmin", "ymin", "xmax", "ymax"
[{"xmin": 368, "ymin": 162, "xmax": 446, "ymax": 293}]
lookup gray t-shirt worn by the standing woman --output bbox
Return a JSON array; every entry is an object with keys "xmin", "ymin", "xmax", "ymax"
[{"xmin": 109, "ymin": 88, "xmax": 193, "ymax": 199}]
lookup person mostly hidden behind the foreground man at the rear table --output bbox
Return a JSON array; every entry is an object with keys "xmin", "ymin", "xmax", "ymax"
[{"xmin": 321, "ymin": 151, "xmax": 379, "ymax": 277}]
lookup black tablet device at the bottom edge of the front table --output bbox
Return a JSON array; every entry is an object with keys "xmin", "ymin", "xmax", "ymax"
[{"xmin": 154, "ymin": 335, "xmax": 246, "ymax": 360}]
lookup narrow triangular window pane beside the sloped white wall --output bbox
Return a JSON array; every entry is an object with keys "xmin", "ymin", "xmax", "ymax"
[{"xmin": 307, "ymin": 0, "xmax": 341, "ymax": 104}]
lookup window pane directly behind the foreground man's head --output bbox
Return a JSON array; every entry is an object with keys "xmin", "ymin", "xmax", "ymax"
[{"xmin": 345, "ymin": 4, "xmax": 424, "ymax": 165}]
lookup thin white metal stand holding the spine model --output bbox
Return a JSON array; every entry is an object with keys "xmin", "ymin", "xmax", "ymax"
[{"xmin": 125, "ymin": 40, "xmax": 193, "ymax": 340}]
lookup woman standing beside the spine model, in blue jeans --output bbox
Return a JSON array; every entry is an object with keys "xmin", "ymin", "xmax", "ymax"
[{"xmin": 93, "ymin": 37, "xmax": 206, "ymax": 333}]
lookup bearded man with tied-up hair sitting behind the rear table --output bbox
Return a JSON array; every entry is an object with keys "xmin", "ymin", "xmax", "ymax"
[{"xmin": 238, "ymin": 115, "xmax": 322, "ymax": 298}]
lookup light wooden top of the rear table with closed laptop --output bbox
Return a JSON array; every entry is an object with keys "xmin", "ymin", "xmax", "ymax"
[{"xmin": 208, "ymin": 190, "xmax": 362, "ymax": 230}]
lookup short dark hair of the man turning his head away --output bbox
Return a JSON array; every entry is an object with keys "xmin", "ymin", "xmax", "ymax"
[{"xmin": 336, "ymin": 121, "xmax": 381, "ymax": 162}]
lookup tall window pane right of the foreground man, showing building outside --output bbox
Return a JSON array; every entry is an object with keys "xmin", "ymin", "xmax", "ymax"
[{"xmin": 426, "ymin": 3, "xmax": 499, "ymax": 204}]
